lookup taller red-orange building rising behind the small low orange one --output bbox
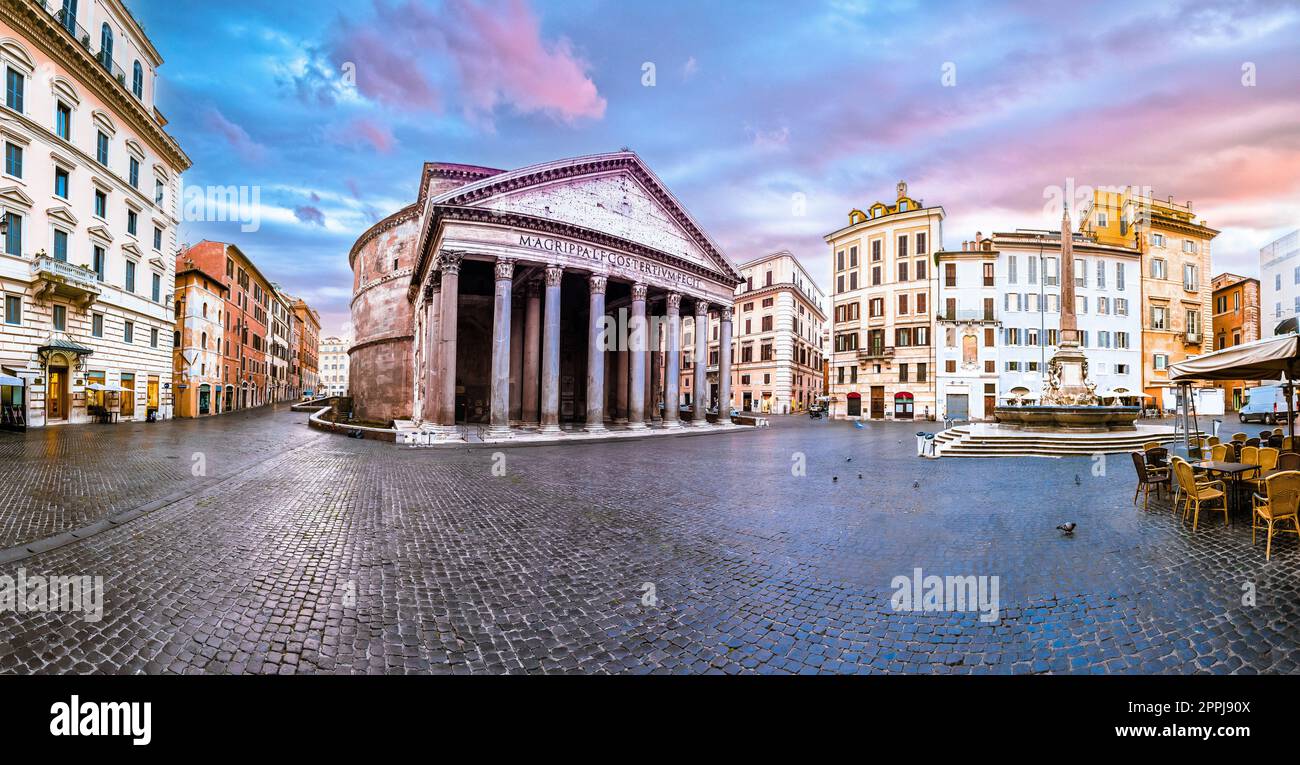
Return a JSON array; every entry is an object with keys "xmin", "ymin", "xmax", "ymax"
[{"xmin": 182, "ymin": 241, "xmax": 273, "ymax": 412}]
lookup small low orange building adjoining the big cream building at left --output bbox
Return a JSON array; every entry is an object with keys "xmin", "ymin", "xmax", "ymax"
[{"xmin": 172, "ymin": 256, "xmax": 230, "ymax": 418}]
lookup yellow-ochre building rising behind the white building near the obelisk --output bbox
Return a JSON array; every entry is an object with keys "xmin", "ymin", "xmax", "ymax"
[{"xmin": 1079, "ymin": 187, "xmax": 1218, "ymax": 406}]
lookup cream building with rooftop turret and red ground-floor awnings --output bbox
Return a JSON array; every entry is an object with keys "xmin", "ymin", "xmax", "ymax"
[{"xmin": 826, "ymin": 182, "xmax": 944, "ymax": 420}]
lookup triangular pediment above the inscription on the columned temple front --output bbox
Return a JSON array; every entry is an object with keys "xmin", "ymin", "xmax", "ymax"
[{"xmin": 434, "ymin": 152, "xmax": 740, "ymax": 281}]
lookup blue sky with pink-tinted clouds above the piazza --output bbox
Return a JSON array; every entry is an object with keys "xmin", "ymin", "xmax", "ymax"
[{"xmin": 127, "ymin": 0, "xmax": 1300, "ymax": 334}]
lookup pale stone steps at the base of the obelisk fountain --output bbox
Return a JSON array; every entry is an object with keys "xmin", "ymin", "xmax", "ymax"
[{"xmin": 935, "ymin": 425, "xmax": 1182, "ymax": 457}]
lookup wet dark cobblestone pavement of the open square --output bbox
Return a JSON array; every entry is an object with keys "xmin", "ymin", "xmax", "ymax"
[{"xmin": 0, "ymin": 409, "xmax": 1300, "ymax": 674}]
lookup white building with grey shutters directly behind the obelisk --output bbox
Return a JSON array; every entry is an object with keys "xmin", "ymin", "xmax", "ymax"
[{"xmin": 982, "ymin": 229, "xmax": 1141, "ymax": 401}]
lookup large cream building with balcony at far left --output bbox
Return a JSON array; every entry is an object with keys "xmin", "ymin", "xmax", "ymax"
[{"xmin": 0, "ymin": 0, "xmax": 190, "ymax": 427}]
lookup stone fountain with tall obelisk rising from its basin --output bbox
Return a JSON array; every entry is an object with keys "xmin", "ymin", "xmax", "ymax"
[{"xmin": 993, "ymin": 207, "xmax": 1141, "ymax": 432}]
